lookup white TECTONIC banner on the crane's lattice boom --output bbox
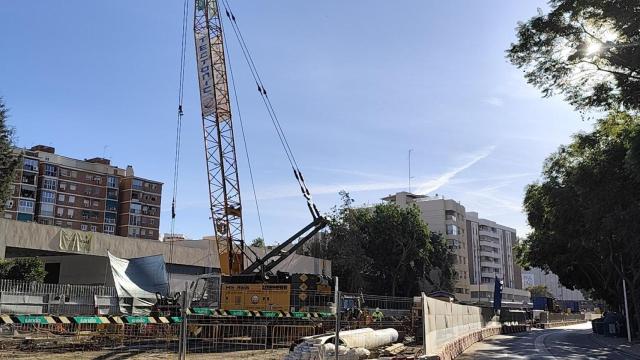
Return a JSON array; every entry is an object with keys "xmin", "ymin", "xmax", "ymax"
[{"xmin": 196, "ymin": 31, "xmax": 216, "ymax": 116}]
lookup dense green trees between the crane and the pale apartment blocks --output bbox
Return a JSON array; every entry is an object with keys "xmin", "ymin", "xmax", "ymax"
[{"xmin": 327, "ymin": 192, "xmax": 455, "ymax": 296}]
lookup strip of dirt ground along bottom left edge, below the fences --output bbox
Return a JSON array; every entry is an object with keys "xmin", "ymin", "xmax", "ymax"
[{"xmin": 0, "ymin": 349, "xmax": 288, "ymax": 360}]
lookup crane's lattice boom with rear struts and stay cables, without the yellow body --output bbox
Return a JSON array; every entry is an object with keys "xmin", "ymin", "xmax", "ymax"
[{"xmin": 193, "ymin": 0, "xmax": 327, "ymax": 280}]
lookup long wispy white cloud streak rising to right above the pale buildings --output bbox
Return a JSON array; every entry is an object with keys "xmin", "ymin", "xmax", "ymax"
[{"xmin": 260, "ymin": 146, "xmax": 495, "ymax": 200}]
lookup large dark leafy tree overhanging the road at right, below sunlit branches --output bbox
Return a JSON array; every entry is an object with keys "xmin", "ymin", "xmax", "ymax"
[{"xmin": 517, "ymin": 112, "xmax": 640, "ymax": 329}]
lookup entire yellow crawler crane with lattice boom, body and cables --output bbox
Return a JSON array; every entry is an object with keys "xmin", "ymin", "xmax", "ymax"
[{"xmin": 159, "ymin": 0, "xmax": 331, "ymax": 311}]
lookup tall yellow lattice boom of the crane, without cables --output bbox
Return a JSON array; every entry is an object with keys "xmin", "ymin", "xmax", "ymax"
[{"xmin": 193, "ymin": 0, "xmax": 244, "ymax": 275}]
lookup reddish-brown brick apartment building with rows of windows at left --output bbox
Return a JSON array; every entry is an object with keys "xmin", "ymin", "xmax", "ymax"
[{"xmin": 3, "ymin": 145, "xmax": 162, "ymax": 239}]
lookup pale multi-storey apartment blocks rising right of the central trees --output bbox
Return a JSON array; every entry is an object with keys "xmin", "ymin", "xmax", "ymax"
[{"xmin": 382, "ymin": 192, "xmax": 530, "ymax": 306}]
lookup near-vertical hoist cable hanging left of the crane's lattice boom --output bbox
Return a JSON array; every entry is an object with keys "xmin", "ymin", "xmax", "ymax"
[{"xmin": 169, "ymin": 0, "xmax": 189, "ymax": 283}]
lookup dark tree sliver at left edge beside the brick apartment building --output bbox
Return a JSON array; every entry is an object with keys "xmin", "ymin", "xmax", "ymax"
[{"xmin": 0, "ymin": 98, "xmax": 20, "ymax": 208}]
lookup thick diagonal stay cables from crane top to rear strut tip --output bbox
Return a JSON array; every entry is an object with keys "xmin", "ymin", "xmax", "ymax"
[{"xmin": 222, "ymin": 0, "xmax": 320, "ymax": 219}]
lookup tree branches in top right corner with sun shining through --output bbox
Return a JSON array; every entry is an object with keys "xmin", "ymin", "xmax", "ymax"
[{"xmin": 507, "ymin": 0, "xmax": 640, "ymax": 110}]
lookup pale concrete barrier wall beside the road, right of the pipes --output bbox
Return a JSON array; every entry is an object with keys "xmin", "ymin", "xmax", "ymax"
[{"xmin": 422, "ymin": 294, "xmax": 500, "ymax": 355}]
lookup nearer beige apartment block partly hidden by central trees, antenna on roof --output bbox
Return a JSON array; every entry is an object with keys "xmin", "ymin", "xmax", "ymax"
[{"xmin": 382, "ymin": 191, "xmax": 471, "ymax": 302}]
